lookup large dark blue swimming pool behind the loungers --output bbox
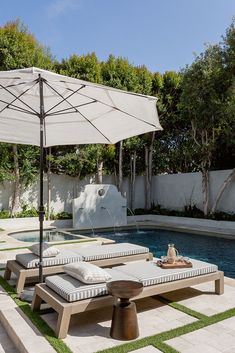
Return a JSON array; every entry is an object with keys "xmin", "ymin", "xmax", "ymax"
[{"xmin": 72, "ymin": 229, "xmax": 235, "ymax": 278}]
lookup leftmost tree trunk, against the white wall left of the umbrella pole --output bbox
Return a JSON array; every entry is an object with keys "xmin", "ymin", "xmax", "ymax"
[{"xmin": 11, "ymin": 145, "xmax": 20, "ymax": 216}]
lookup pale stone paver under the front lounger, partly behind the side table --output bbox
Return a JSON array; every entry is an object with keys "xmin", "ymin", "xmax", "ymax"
[{"xmin": 42, "ymin": 297, "xmax": 196, "ymax": 353}]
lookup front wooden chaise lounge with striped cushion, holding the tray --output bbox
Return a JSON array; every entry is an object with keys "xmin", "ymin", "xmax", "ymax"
[{"xmin": 32, "ymin": 260, "xmax": 224, "ymax": 338}]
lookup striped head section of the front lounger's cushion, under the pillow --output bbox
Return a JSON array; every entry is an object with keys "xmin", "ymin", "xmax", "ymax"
[{"xmin": 45, "ymin": 269, "xmax": 136, "ymax": 302}]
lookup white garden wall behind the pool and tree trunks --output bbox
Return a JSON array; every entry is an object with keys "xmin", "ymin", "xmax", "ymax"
[{"xmin": 0, "ymin": 170, "xmax": 235, "ymax": 213}]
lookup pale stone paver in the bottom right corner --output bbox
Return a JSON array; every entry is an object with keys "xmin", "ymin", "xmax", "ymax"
[{"xmin": 165, "ymin": 317, "xmax": 235, "ymax": 353}]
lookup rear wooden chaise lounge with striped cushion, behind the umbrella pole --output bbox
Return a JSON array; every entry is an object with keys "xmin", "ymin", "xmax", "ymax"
[{"xmin": 4, "ymin": 243, "xmax": 152, "ymax": 294}]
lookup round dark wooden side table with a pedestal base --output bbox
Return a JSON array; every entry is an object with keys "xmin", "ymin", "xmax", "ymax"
[{"xmin": 107, "ymin": 280, "xmax": 143, "ymax": 340}]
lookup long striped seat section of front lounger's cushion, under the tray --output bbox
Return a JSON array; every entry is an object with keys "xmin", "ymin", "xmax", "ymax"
[{"xmin": 115, "ymin": 260, "xmax": 218, "ymax": 287}]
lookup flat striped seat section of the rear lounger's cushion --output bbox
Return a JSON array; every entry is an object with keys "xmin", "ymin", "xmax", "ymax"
[{"xmin": 73, "ymin": 243, "xmax": 149, "ymax": 261}]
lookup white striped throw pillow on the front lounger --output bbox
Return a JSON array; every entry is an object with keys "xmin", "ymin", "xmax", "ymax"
[{"xmin": 64, "ymin": 262, "xmax": 112, "ymax": 284}]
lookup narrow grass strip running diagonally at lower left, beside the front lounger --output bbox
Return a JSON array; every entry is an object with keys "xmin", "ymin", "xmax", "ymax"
[{"xmin": 0, "ymin": 276, "xmax": 72, "ymax": 353}]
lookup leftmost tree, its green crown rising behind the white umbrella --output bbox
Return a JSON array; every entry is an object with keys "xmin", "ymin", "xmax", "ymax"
[{"xmin": 0, "ymin": 20, "xmax": 53, "ymax": 214}]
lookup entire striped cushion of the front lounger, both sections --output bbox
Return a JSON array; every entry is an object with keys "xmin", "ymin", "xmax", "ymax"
[{"xmin": 45, "ymin": 260, "xmax": 218, "ymax": 302}]
